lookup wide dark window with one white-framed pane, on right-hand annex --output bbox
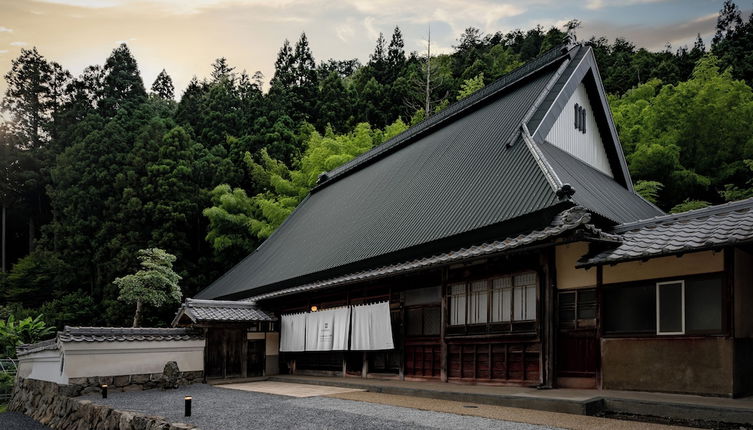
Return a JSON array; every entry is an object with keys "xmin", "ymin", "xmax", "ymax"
[{"xmin": 604, "ymin": 276, "xmax": 724, "ymax": 335}]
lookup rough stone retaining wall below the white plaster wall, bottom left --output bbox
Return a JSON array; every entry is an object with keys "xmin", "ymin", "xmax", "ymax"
[{"xmin": 8, "ymin": 374, "xmax": 203, "ymax": 430}]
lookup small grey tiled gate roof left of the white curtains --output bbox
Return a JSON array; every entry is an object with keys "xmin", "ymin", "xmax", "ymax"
[{"xmin": 172, "ymin": 299, "xmax": 277, "ymax": 326}]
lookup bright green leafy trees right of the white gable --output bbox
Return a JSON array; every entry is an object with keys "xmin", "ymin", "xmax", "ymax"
[{"xmin": 611, "ymin": 55, "xmax": 753, "ymax": 208}]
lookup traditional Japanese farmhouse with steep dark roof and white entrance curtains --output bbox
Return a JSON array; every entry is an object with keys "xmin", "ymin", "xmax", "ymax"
[{"xmin": 179, "ymin": 45, "xmax": 753, "ymax": 396}]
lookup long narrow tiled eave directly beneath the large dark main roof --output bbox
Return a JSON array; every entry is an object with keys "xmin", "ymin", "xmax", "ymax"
[{"xmin": 247, "ymin": 206, "xmax": 619, "ymax": 302}]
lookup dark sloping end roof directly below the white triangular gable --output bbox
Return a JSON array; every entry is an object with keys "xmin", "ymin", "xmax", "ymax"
[{"xmin": 539, "ymin": 143, "xmax": 664, "ymax": 223}]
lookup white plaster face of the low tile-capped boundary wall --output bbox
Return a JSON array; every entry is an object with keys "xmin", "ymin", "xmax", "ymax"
[{"xmin": 62, "ymin": 340, "xmax": 204, "ymax": 378}]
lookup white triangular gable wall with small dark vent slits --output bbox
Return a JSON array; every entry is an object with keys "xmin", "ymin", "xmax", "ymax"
[{"xmin": 546, "ymin": 82, "xmax": 614, "ymax": 177}]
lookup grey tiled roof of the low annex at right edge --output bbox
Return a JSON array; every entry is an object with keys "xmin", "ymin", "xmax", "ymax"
[{"xmin": 579, "ymin": 198, "xmax": 753, "ymax": 267}]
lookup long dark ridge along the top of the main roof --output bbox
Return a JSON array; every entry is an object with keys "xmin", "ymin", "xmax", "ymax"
[{"xmin": 311, "ymin": 44, "xmax": 581, "ymax": 193}]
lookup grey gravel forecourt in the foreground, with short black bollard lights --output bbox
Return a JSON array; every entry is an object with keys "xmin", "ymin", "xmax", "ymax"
[{"xmin": 85, "ymin": 384, "xmax": 552, "ymax": 430}]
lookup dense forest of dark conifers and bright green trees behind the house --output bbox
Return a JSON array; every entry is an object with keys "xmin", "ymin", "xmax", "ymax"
[{"xmin": 0, "ymin": 1, "xmax": 753, "ymax": 326}]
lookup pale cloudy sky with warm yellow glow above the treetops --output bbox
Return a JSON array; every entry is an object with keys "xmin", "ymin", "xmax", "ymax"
[{"xmin": 0, "ymin": 0, "xmax": 736, "ymax": 94}]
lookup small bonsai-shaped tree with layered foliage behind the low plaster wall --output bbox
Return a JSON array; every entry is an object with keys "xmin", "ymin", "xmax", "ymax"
[{"xmin": 113, "ymin": 248, "xmax": 183, "ymax": 327}]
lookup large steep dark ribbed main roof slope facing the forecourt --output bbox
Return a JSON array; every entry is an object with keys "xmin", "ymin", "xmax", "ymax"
[{"xmin": 196, "ymin": 45, "xmax": 660, "ymax": 299}]
